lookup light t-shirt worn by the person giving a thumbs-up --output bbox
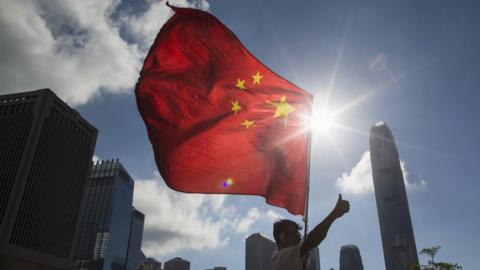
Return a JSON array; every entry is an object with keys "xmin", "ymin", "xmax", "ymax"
[{"xmin": 272, "ymin": 242, "xmax": 310, "ymax": 270}]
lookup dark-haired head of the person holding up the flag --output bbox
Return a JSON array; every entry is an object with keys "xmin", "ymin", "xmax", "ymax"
[{"xmin": 273, "ymin": 219, "xmax": 302, "ymax": 248}]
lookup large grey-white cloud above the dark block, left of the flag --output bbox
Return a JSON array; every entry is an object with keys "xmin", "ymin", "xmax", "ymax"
[{"xmin": 0, "ymin": 0, "xmax": 208, "ymax": 105}]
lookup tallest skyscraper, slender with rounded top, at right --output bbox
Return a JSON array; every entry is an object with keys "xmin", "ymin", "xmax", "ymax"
[{"xmin": 370, "ymin": 122, "xmax": 418, "ymax": 270}]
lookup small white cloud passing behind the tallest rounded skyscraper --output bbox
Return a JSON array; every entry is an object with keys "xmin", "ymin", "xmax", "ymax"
[{"xmin": 336, "ymin": 151, "xmax": 427, "ymax": 194}]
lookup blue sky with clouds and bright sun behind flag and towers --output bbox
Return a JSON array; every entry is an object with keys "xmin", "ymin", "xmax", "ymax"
[{"xmin": 0, "ymin": 0, "xmax": 480, "ymax": 270}]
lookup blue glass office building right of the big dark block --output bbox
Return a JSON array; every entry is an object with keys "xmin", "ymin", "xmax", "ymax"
[{"xmin": 74, "ymin": 160, "xmax": 144, "ymax": 269}]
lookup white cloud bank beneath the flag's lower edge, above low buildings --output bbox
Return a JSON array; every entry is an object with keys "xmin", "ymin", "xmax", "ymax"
[{"xmin": 134, "ymin": 173, "xmax": 280, "ymax": 257}]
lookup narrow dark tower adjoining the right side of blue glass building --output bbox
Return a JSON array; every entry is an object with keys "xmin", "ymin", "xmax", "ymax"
[{"xmin": 127, "ymin": 208, "xmax": 145, "ymax": 270}]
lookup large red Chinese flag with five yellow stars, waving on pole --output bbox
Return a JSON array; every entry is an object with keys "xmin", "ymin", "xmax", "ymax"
[{"xmin": 135, "ymin": 7, "xmax": 312, "ymax": 215}]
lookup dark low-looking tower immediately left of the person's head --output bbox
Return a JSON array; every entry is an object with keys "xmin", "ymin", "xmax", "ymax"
[{"xmin": 245, "ymin": 233, "xmax": 276, "ymax": 270}]
